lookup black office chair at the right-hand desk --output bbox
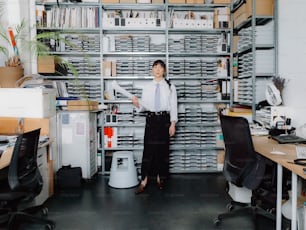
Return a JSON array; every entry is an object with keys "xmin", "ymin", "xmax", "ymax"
[{"xmin": 214, "ymin": 115, "xmax": 275, "ymax": 226}]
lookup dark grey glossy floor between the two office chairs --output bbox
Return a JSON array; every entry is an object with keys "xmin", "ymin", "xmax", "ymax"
[{"xmin": 34, "ymin": 173, "xmax": 275, "ymax": 230}]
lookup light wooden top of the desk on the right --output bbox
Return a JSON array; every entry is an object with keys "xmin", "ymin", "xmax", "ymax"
[{"xmin": 252, "ymin": 136, "xmax": 306, "ymax": 179}]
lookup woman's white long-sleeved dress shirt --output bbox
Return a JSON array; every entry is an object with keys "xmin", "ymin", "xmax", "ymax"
[{"xmin": 140, "ymin": 79, "xmax": 177, "ymax": 122}]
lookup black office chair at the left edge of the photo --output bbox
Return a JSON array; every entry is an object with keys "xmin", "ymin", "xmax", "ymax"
[{"xmin": 0, "ymin": 129, "xmax": 55, "ymax": 230}]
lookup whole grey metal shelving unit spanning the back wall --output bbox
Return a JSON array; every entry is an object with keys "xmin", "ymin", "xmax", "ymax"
[{"xmin": 37, "ymin": 2, "xmax": 232, "ymax": 174}]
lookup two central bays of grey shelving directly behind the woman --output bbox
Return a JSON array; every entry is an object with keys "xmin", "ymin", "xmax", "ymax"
[{"xmin": 102, "ymin": 4, "xmax": 231, "ymax": 173}]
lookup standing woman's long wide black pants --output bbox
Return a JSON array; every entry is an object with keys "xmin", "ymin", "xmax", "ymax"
[{"xmin": 141, "ymin": 114, "xmax": 170, "ymax": 180}]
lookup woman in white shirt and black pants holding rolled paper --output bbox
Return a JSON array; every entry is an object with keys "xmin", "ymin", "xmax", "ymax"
[{"xmin": 132, "ymin": 60, "xmax": 177, "ymax": 194}]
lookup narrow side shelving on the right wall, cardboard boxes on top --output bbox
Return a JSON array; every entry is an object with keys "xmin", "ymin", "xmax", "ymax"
[{"xmin": 231, "ymin": 0, "xmax": 277, "ymax": 120}]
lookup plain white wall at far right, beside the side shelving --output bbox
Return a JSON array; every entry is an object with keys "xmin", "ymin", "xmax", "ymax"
[{"xmin": 275, "ymin": 0, "xmax": 306, "ymax": 127}]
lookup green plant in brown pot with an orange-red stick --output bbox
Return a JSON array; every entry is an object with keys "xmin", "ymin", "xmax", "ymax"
[{"xmin": 0, "ymin": 20, "xmax": 78, "ymax": 88}]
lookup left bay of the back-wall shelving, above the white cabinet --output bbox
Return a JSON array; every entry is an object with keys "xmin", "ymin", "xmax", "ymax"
[{"xmin": 36, "ymin": 2, "xmax": 102, "ymax": 102}]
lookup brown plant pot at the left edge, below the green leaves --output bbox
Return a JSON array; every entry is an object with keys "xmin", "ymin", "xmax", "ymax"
[{"xmin": 0, "ymin": 66, "xmax": 23, "ymax": 88}]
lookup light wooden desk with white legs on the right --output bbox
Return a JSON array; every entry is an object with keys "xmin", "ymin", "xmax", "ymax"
[{"xmin": 253, "ymin": 136, "xmax": 306, "ymax": 230}]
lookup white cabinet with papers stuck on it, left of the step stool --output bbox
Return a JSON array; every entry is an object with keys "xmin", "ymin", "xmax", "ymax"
[{"xmin": 57, "ymin": 111, "xmax": 97, "ymax": 179}]
